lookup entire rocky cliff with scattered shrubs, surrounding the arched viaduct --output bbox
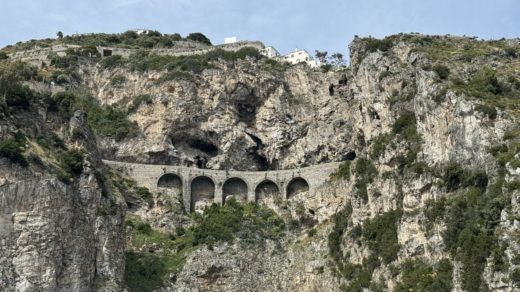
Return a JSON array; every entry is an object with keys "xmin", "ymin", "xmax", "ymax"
[{"xmin": 0, "ymin": 34, "xmax": 520, "ymax": 291}]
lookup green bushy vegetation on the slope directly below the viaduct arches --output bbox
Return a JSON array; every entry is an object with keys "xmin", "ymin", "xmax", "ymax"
[{"xmin": 125, "ymin": 200, "xmax": 285, "ymax": 291}]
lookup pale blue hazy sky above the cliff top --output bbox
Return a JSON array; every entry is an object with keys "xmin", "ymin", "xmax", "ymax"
[{"xmin": 0, "ymin": 0, "xmax": 520, "ymax": 55}]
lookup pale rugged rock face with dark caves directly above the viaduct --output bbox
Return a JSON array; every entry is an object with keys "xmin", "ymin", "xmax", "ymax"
[{"xmin": 85, "ymin": 61, "xmax": 354, "ymax": 170}]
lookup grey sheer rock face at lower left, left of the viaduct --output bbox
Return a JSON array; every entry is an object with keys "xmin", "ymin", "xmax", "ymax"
[{"xmin": 0, "ymin": 112, "xmax": 125, "ymax": 291}]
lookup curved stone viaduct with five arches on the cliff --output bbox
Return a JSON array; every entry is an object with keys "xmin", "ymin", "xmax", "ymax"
[{"xmin": 103, "ymin": 160, "xmax": 340, "ymax": 212}]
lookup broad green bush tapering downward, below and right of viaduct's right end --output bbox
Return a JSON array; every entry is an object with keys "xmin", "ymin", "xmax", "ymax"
[{"xmin": 362, "ymin": 210, "xmax": 402, "ymax": 264}]
